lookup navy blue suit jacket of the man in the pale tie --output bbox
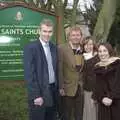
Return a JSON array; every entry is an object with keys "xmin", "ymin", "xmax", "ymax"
[{"xmin": 24, "ymin": 40, "xmax": 57, "ymax": 120}]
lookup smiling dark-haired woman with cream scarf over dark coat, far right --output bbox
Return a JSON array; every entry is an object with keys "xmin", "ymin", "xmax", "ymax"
[{"xmin": 93, "ymin": 43, "xmax": 120, "ymax": 120}]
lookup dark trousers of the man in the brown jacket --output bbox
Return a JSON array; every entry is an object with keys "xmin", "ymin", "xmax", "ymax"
[{"xmin": 64, "ymin": 87, "xmax": 83, "ymax": 120}]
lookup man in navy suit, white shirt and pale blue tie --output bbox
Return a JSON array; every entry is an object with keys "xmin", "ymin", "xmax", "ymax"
[{"xmin": 24, "ymin": 19, "xmax": 57, "ymax": 120}]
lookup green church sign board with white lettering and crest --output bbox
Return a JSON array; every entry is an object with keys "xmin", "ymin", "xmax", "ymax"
[{"xmin": 0, "ymin": 5, "xmax": 56, "ymax": 80}]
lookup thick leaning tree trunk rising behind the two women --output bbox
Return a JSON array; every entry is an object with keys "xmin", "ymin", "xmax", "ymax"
[{"xmin": 93, "ymin": 0, "xmax": 117, "ymax": 42}]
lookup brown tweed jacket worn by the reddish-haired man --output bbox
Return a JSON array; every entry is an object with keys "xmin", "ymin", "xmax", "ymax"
[{"xmin": 58, "ymin": 43, "xmax": 84, "ymax": 96}]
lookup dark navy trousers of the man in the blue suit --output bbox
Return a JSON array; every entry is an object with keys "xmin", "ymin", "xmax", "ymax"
[{"xmin": 29, "ymin": 84, "xmax": 56, "ymax": 120}]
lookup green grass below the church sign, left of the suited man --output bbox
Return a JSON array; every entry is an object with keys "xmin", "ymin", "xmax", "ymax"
[{"xmin": 0, "ymin": 80, "xmax": 28, "ymax": 120}]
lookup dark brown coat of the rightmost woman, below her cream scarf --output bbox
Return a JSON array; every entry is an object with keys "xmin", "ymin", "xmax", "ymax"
[{"xmin": 93, "ymin": 59, "xmax": 120, "ymax": 120}]
